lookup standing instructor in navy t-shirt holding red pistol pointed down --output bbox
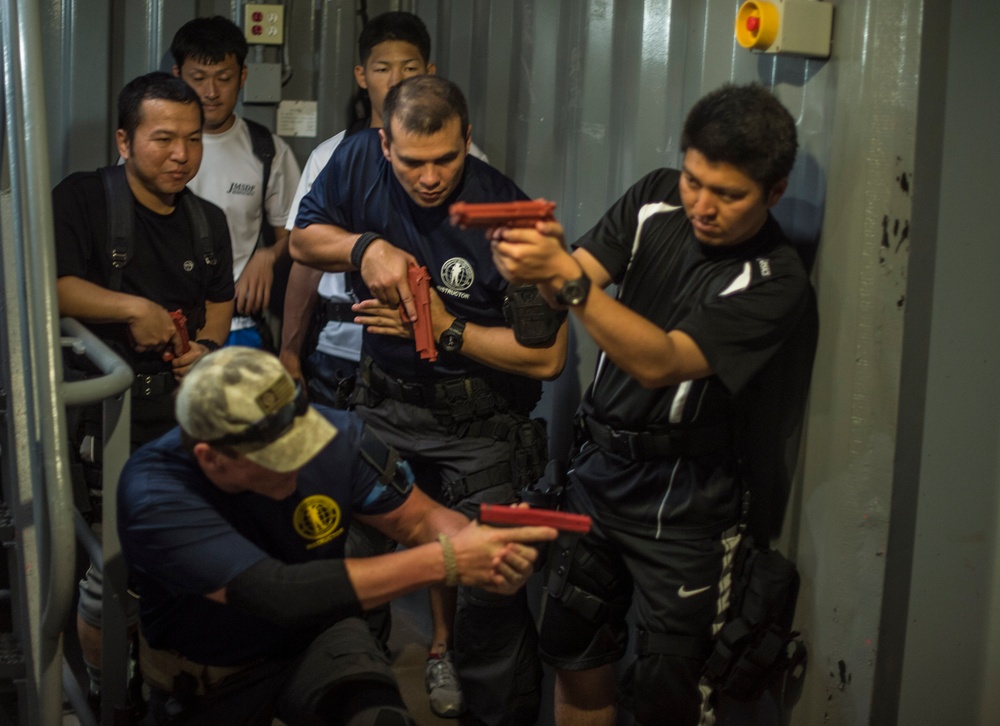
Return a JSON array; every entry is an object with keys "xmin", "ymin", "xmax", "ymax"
[{"xmin": 290, "ymin": 76, "xmax": 567, "ymax": 726}]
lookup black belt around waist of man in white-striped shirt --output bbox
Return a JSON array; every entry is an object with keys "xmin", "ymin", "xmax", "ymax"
[{"xmin": 583, "ymin": 417, "xmax": 733, "ymax": 461}]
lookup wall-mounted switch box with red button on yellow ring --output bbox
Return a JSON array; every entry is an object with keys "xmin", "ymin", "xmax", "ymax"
[{"xmin": 736, "ymin": 0, "xmax": 833, "ymax": 58}]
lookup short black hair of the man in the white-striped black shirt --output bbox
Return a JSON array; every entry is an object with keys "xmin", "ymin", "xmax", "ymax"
[{"xmin": 681, "ymin": 83, "xmax": 798, "ymax": 193}]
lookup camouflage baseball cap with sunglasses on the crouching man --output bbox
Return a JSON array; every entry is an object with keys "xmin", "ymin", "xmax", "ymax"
[{"xmin": 176, "ymin": 346, "xmax": 337, "ymax": 472}]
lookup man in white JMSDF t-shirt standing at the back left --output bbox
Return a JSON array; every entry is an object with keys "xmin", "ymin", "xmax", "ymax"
[{"xmin": 170, "ymin": 15, "xmax": 299, "ymax": 347}]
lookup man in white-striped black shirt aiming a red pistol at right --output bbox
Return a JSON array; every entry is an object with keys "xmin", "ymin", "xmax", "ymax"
[{"xmin": 492, "ymin": 85, "xmax": 813, "ymax": 726}]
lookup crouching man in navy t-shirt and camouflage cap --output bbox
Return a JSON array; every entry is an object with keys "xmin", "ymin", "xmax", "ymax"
[{"xmin": 118, "ymin": 346, "xmax": 556, "ymax": 726}]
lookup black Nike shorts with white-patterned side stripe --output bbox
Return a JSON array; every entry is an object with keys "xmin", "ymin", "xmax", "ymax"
[{"xmin": 539, "ymin": 507, "xmax": 740, "ymax": 726}]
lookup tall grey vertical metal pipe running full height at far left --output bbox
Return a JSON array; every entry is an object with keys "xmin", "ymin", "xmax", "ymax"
[{"xmin": 2, "ymin": 0, "xmax": 75, "ymax": 726}]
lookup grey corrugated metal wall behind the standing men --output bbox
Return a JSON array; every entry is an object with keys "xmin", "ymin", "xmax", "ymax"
[{"xmin": 46, "ymin": 0, "xmax": 832, "ymax": 243}]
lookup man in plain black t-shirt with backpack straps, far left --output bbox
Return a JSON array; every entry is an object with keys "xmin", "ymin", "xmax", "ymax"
[{"xmin": 52, "ymin": 73, "xmax": 233, "ymax": 712}]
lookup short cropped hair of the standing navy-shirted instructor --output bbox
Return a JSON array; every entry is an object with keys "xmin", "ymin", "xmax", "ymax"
[{"xmin": 382, "ymin": 76, "xmax": 469, "ymax": 143}]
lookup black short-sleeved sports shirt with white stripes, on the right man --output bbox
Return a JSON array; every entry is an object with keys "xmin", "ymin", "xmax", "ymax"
[{"xmin": 573, "ymin": 169, "xmax": 811, "ymax": 537}]
